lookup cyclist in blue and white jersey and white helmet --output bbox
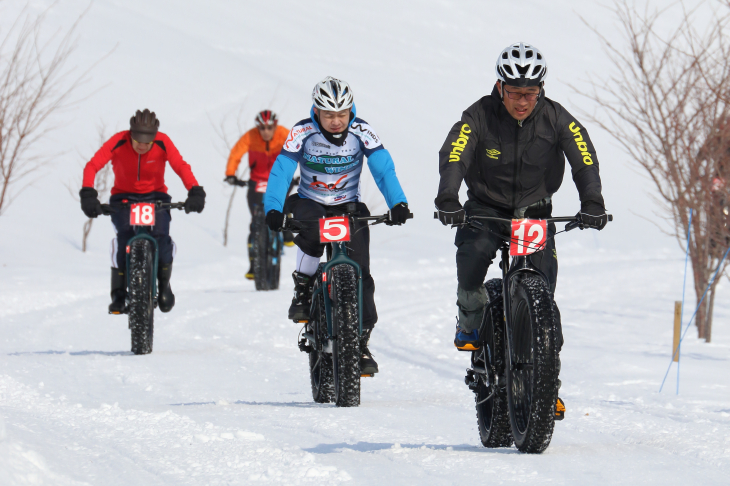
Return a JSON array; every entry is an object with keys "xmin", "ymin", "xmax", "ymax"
[{"xmin": 264, "ymin": 76, "xmax": 409, "ymax": 374}]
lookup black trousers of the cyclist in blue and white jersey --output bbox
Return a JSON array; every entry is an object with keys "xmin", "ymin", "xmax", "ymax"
[{"xmin": 285, "ymin": 194, "xmax": 378, "ymax": 329}]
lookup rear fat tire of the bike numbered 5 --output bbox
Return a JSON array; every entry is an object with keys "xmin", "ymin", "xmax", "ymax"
[{"xmin": 308, "ymin": 274, "xmax": 335, "ymax": 403}]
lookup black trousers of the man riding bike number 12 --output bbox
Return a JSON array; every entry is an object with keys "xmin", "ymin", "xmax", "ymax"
[{"xmin": 454, "ymin": 200, "xmax": 558, "ymax": 293}]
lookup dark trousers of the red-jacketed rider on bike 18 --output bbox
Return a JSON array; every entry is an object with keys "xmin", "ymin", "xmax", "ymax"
[{"xmin": 109, "ymin": 192, "xmax": 174, "ymax": 269}]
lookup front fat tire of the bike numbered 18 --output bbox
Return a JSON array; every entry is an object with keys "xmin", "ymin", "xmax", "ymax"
[{"xmin": 127, "ymin": 238, "xmax": 155, "ymax": 354}]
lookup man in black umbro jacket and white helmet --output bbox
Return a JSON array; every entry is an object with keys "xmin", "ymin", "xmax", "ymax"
[{"xmin": 435, "ymin": 43, "xmax": 607, "ymax": 360}]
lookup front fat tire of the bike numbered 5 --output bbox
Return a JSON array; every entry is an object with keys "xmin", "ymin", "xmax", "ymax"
[{"xmin": 329, "ymin": 264, "xmax": 360, "ymax": 407}]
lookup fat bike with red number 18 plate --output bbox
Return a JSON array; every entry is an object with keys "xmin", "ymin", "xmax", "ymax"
[{"xmin": 101, "ymin": 201, "xmax": 185, "ymax": 354}]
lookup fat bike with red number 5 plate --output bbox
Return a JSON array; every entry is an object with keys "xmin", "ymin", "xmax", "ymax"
[{"xmin": 285, "ymin": 203, "xmax": 413, "ymax": 407}]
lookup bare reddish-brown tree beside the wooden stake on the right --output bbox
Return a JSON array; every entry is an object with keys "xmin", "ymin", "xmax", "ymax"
[{"xmin": 573, "ymin": 0, "xmax": 730, "ymax": 342}]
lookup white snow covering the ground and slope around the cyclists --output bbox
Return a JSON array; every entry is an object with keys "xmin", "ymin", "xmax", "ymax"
[{"xmin": 0, "ymin": 0, "xmax": 730, "ymax": 485}]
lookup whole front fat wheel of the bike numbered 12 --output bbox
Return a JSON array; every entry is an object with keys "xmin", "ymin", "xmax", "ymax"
[{"xmin": 507, "ymin": 276, "xmax": 558, "ymax": 453}]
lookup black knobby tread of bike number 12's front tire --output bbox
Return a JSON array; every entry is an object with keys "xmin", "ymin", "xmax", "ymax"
[{"xmin": 507, "ymin": 276, "xmax": 558, "ymax": 453}]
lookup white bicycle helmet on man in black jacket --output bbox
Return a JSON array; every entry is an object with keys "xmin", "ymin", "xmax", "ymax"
[{"xmin": 494, "ymin": 42, "xmax": 547, "ymax": 88}]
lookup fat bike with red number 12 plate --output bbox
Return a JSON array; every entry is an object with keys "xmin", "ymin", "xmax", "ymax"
[{"xmin": 435, "ymin": 215, "xmax": 613, "ymax": 453}]
